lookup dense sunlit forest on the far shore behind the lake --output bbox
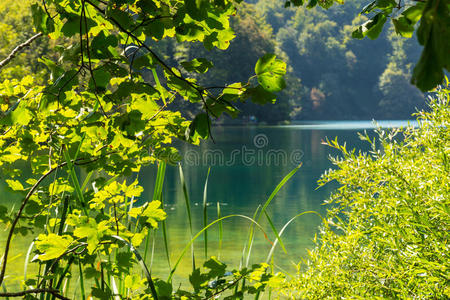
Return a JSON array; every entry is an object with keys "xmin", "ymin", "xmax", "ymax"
[{"xmin": 0, "ymin": 0, "xmax": 424, "ymax": 124}]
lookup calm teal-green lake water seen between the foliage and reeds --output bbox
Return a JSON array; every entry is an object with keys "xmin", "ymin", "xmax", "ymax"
[{"xmin": 0, "ymin": 121, "xmax": 416, "ymax": 281}]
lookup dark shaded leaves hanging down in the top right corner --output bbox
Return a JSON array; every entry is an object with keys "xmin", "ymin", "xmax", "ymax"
[{"xmin": 285, "ymin": 0, "xmax": 450, "ymax": 92}]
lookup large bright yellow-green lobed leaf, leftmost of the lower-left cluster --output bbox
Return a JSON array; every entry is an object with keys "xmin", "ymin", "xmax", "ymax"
[{"xmin": 36, "ymin": 233, "xmax": 73, "ymax": 261}]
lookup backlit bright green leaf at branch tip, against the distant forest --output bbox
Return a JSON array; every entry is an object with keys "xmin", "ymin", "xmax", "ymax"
[{"xmin": 255, "ymin": 54, "xmax": 286, "ymax": 92}]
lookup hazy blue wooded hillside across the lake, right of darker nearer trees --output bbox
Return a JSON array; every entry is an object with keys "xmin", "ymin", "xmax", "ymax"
[{"xmin": 255, "ymin": 0, "xmax": 424, "ymax": 120}]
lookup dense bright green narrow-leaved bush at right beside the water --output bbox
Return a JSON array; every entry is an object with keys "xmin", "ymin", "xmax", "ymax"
[{"xmin": 280, "ymin": 83, "xmax": 450, "ymax": 299}]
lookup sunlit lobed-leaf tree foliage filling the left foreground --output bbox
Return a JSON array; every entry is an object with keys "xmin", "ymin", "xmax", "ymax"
[{"xmin": 0, "ymin": 0, "xmax": 286, "ymax": 299}]
